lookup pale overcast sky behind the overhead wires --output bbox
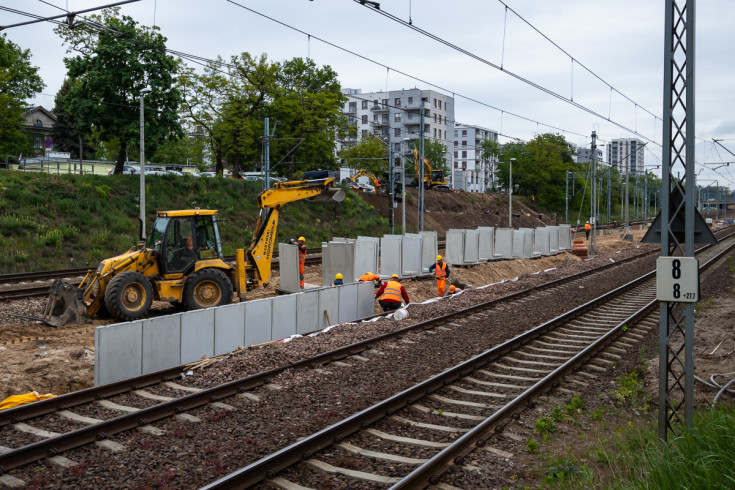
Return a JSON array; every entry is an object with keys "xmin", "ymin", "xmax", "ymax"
[{"xmin": 5, "ymin": 0, "xmax": 735, "ymax": 188}]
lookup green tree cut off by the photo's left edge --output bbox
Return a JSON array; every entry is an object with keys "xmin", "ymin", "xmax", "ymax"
[{"xmin": 0, "ymin": 34, "xmax": 44, "ymax": 154}]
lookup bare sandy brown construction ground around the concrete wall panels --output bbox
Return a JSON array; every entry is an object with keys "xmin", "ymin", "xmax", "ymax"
[{"xmin": 0, "ymin": 227, "xmax": 668, "ymax": 399}]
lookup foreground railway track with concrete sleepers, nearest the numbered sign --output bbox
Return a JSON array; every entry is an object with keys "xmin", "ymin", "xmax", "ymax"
[{"xmin": 203, "ymin": 232, "xmax": 735, "ymax": 489}]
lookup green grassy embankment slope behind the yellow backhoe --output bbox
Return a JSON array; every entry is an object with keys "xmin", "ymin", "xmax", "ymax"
[{"xmin": 0, "ymin": 171, "xmax": 388, "ymax": 274}]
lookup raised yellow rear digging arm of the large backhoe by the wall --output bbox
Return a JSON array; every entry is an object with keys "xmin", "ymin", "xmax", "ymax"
[{"xmin": 242, "ymin": 178, "xmax": 345, "ymax": 289}]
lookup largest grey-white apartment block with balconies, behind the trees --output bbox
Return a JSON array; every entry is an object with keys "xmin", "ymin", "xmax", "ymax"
[{"xmin": 336, "ymin": 88, "xmax": 454, "ymax": 179}]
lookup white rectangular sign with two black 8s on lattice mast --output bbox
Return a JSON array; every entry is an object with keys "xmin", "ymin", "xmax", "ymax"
[{"xmin": 656, "ymin": 257, "xmax": 699, "ymax": 303}]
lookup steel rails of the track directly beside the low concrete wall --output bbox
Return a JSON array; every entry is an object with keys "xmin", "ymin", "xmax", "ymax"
[{"xmin": 0, "ymin": 242, "xmax": 668, "ymax": 474}]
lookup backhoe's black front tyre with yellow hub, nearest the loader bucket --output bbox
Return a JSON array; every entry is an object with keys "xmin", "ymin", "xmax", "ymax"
[{"xmin": 105, "ymin": 271, "xmax": 153, "ymax": 321}]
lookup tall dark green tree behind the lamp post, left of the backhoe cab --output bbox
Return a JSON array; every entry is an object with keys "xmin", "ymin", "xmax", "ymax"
[{"xmin": 55, "ymin": 8, "xmax": 183, "ymax": 174}]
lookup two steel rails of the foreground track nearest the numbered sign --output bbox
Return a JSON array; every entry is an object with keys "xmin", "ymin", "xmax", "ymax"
[{"xmin": 202, "ymin": 233, "xmax": 735, "ymax": 489}]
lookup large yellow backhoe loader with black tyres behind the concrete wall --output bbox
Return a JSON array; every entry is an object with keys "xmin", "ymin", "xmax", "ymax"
[{"xmin": 40, "ymin": 178, "xmax": 345, "ymax": 327}]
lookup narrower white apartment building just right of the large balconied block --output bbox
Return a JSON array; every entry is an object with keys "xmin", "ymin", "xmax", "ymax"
[{"xmin": 452, "ymin": 123, "xmax": 498, "ymax": 192}]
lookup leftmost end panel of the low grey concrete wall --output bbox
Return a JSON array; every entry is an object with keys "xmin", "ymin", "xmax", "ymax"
[{"xmin": 94, "ymin": 321, "xmax": 143, "ymax": 386}]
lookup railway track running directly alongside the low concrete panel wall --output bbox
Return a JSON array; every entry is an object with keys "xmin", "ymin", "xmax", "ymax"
[{"xmin": 0, "ymin": 232, "xmax": 732, "ymax": 488}]
